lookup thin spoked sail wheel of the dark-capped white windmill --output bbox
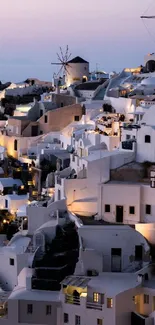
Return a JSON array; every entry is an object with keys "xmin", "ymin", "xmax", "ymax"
[{"xmin": 51, "ymin": 45, "xmax": 71, "ymax": 77}]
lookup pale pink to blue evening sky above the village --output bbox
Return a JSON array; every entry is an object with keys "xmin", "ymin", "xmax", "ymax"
[{"xmin": 0, "ymin": 0, "xmax": 155, "ymax": 81}]
